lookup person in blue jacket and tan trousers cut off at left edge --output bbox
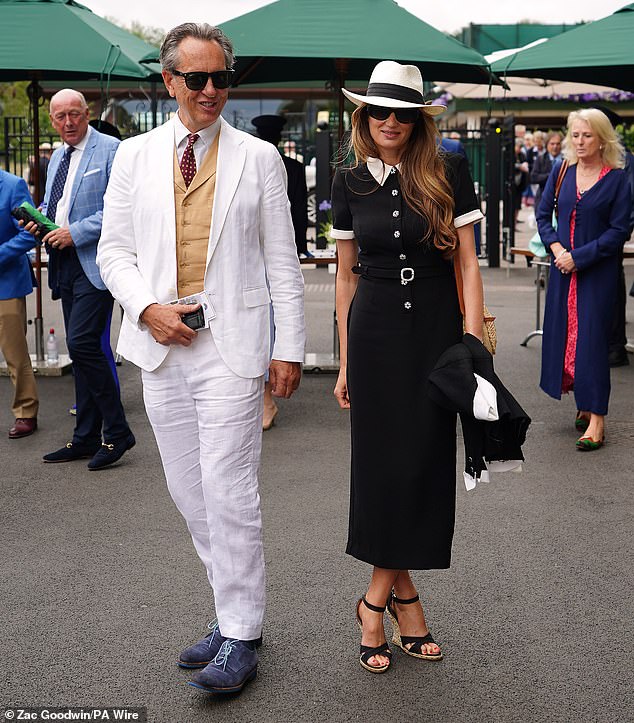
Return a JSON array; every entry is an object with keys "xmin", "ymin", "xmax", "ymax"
[{"xmin": 0, "ymin": 171, "xmax": 39, "ymax": 439}]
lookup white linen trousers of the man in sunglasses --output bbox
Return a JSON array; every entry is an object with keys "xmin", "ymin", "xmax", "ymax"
[{"xmin": 142, "ymin": 329, "xmax": 265, "ymax": 640}]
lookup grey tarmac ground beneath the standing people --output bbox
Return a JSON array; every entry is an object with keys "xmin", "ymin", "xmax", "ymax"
[{"xmin": 0, "ymin": 211, "xmax": 634, "ymax": 723}]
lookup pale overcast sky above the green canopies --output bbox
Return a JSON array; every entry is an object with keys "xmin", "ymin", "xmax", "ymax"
[{"xmin": 87, "ymin": 0, "xmax": 628, "ymax": 33}]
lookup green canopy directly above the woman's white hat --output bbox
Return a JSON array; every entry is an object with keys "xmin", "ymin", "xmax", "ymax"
[{"xmin": 221, "ymin": 0, "xmax": 489, "ymax": 85}]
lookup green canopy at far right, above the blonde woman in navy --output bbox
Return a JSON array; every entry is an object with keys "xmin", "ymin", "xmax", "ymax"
[{"xmin": 491, "ymin": 3, "xmax": 634, "ymax": 91}]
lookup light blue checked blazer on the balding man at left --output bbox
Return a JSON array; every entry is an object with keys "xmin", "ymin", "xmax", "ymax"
[{"xmin": 42, "ymin": 127, "xmax": 119, "ymax": 290}]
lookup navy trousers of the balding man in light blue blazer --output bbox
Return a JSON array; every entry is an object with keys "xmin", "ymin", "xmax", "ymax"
[{"xmin": 56, "ymin": 247, "xmax": 130, "ymax": 445}]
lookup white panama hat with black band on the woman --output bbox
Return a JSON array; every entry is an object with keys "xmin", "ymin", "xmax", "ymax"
[{"xmin": 341, "ymin": 60, "xmax": 447, "ymax": 115}]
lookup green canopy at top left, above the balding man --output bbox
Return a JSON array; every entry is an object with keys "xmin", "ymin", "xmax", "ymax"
[{"xmin": 0, "ymin": 0, "xmax": 156, "ymax": 82}]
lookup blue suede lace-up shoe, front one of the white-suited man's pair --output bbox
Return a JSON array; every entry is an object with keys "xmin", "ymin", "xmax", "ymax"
[{"xmin": 189, "ymin": 636, "xmax": 258, "ymax": 693}]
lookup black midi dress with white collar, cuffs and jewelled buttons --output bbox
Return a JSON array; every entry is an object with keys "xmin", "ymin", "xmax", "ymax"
[{"xmin": 332, "ymin": 154, "xmax": 482, "ymax": 570}]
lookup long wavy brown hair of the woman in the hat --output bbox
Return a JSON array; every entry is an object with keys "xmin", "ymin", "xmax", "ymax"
[{"xmin": 346, "ymin": 106, "xmax": 458, "ymax": 257}]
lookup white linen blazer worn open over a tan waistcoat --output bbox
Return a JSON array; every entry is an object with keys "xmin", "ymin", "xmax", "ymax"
[{"xmin": 97, "ymin": 119, "xmax": 305, "ymax": 377}]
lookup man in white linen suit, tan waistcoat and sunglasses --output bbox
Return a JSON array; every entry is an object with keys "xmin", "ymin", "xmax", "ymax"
[{"xmin": 97, "ymin": 23, "xmax": 305, "ymax": 693}]
